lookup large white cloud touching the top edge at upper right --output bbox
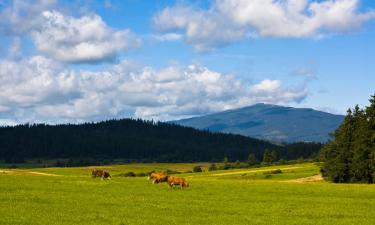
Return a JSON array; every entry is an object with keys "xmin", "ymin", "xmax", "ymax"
[{"xmin": 153, "ymin": 0, "xmax": 375, "ymax": 51}]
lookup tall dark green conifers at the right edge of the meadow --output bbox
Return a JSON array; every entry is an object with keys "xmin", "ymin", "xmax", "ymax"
[{"xmin": 321, "ymin": 95, "xmax": 375, "ymax": 183}]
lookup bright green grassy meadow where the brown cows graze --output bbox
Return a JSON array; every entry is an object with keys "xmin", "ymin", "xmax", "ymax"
[{"xmin": 0, "ymin": 163, "xmax": 375, "ymax": 225}]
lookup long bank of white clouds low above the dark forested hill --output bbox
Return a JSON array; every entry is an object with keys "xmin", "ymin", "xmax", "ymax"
[{"xmin": 0, "ymin": 56, "xmax": 307, "ymax": 123}]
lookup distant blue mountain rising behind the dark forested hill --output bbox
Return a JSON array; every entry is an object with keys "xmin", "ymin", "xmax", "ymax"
[{"xmin": 172, "ymin": 103, "xmax": 344, "ymax": 142}]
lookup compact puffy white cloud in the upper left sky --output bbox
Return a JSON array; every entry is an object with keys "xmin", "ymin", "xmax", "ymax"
[{"xmin": 32, "ymin": 11, "xmax": 140, "ymax": 63}]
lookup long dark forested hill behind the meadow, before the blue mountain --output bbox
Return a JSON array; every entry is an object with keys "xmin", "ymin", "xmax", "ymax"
[{"xmin": 0, "ymin": 119, "xmax": 320, "ymax": 162}]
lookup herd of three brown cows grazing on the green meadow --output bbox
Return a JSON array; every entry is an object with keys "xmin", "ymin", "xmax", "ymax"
[{"xmin": 91, "ymin": 169, "xmax": 189, "ymax": 189}]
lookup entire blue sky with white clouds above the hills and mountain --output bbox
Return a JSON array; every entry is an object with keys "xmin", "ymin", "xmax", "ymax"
[{"xmin": 0, "ymin": 0, "xmax": 375, "ymax": 125}]
